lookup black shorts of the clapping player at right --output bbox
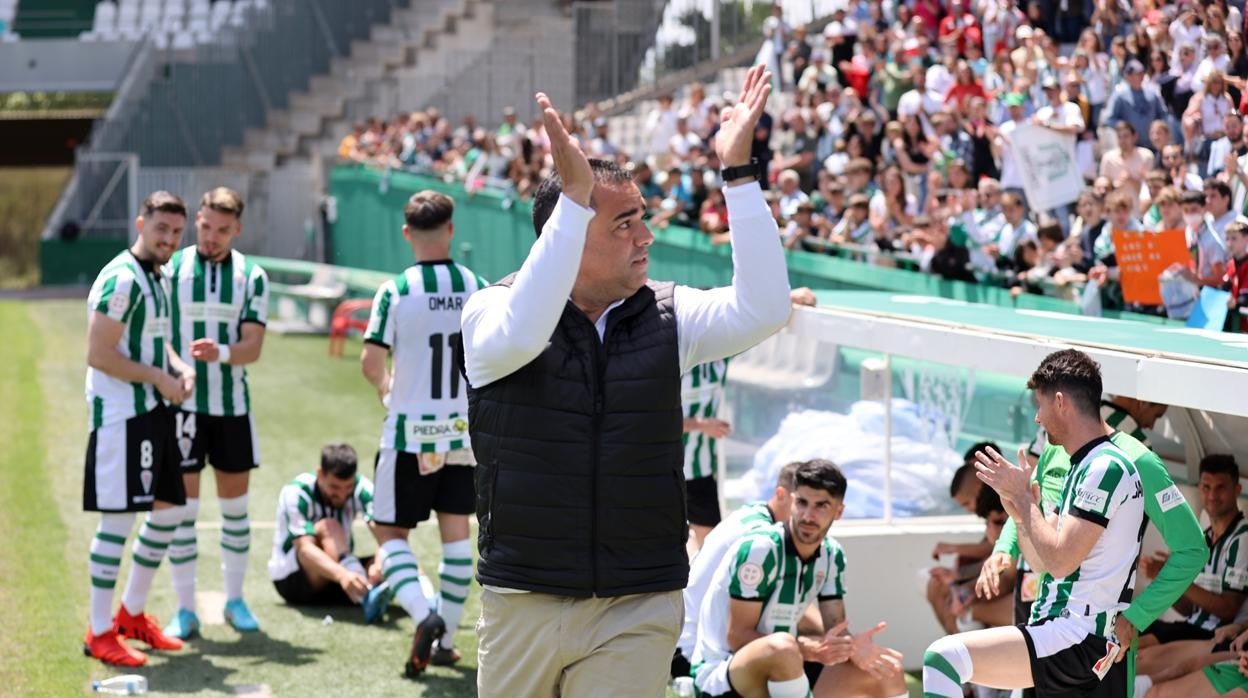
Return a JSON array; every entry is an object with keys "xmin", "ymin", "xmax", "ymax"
[{"xmin": 1018, "ymin": 619, "xmax": 1128, "ymax": 698}]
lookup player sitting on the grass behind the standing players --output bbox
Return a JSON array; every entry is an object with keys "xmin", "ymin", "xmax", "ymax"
[{"xmin": 268, "ymin": 443, "xmax": 384, "ymax": 623}]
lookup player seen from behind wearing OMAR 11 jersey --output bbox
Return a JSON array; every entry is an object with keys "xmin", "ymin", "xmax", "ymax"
[{"xmin": 359, "ymin": 191, "xmax": 485, "ymax": 678}]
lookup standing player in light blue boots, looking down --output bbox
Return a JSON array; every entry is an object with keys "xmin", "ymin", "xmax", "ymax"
[{"xmin": 165, "ymin": 187, "xmax": 268, "ymax": 639}]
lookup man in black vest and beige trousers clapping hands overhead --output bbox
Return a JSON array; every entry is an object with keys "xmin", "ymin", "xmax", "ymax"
[{"xmin": 463, "ymin": 66, "xmax": 790, "ymax": 697}]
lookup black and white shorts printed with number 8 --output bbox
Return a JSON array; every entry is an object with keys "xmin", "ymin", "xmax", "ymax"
[{"xmin": 82, "ymin": 405, "xmax": 186, "ymax": 512}]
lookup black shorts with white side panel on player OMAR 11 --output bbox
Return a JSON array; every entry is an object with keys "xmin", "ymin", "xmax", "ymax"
[{"xmin": 373, "ymin": 448, "xmax": 477, "ymax": 528}]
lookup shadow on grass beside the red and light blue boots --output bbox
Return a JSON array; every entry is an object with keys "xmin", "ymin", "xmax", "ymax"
[{"xmin": 144, "ymin": 633, "xmax": 321, "ymax": 693}]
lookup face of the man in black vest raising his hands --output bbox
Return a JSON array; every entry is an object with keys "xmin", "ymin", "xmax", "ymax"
[{"xmin": 577, "ymin": 182, "xmax": 654, "ymax": 301}]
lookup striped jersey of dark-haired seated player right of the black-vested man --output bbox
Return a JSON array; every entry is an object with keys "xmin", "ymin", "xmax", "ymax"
[{"xmin": 691, "ymin": 523, "xmax": 845, "ymax": 666}]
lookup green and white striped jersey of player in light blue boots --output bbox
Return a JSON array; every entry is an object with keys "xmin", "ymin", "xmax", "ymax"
[{"xmin": 168, "ymin": 246, "xmax": 268, "ymax": 417}]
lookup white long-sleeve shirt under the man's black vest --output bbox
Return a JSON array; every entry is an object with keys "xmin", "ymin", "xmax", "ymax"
[{"xmin": 461, "ymin": 182, "xmax": 790, "ymax": 387}]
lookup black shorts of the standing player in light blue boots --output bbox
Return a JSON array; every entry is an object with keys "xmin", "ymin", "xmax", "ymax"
[{"xmin": 173, "ymin": 410, "xmax": 260, "ymax": 472}]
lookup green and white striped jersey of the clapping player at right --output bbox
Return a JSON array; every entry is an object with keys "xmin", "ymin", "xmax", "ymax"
[{"xmin": 1031, "ymin": 436, "xmax": 1144, "ymax": 636}]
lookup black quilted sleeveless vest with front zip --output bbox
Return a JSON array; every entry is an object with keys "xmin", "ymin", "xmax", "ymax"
[{"xmin": 468, "ymin": 277, "xmax": 689, "ymax": 597}]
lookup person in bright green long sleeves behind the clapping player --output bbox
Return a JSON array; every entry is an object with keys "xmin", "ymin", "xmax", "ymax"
[{"xmin": 976, "ymin": 397, "xmax": 1208, "ymax": 689}]
